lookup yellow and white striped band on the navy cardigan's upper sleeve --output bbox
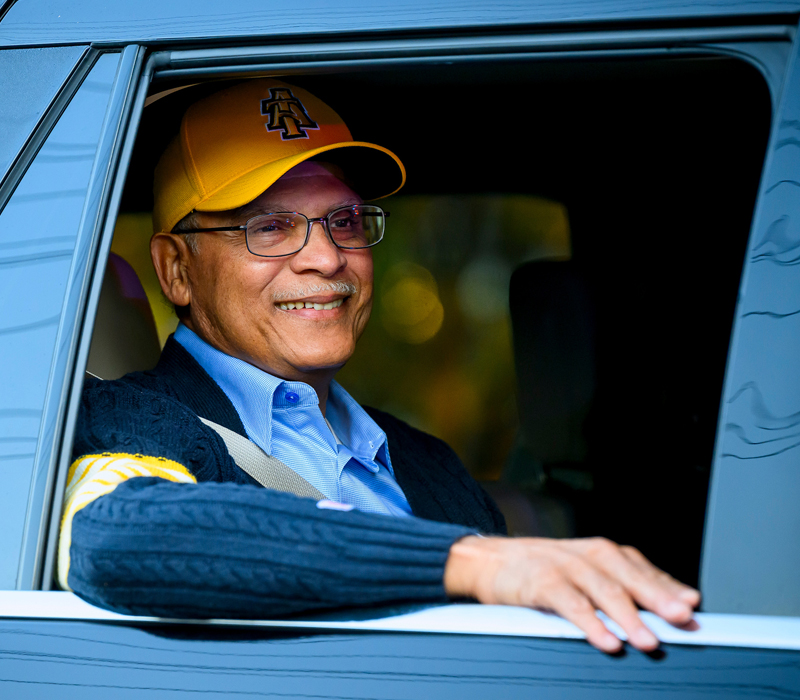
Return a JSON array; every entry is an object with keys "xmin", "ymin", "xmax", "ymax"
[{"xmin": 58, "ymin": 452, "xmax": 197, "ymax": 591}]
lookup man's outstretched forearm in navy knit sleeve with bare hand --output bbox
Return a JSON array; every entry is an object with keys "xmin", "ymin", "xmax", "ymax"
[{"xmin": 68, "ymin": 470, "xmax": 699, "ymax": 651}]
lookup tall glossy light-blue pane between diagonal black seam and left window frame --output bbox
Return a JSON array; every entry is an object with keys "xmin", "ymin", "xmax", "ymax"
[{"xmin": 0, "ymin": 54, "xmax": 119, "ymax": 589}]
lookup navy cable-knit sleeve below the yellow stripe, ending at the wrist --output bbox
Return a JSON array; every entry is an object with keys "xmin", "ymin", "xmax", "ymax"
[{"xmin": 68, "ymin": 477, "xmax": 473, "ymax": 618}]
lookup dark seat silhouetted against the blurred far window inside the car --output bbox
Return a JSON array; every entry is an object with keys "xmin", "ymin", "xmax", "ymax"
[{"xmin": 495, "ymin": 260, "xmax": 595, "ymax": 537}]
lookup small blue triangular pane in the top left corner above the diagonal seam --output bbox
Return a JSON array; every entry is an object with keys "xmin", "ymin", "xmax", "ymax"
[{"xmin": 0, "ymin": 46, "xmax": 85, "ymax": 185}]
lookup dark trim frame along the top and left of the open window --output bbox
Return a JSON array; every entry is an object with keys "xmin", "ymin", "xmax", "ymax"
[{"xmin": 25, "ymin": 25, "xmax": 795, "ymax": 616}]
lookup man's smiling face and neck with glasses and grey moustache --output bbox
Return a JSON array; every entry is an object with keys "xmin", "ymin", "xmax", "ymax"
[{"xmin": 162, "ymin": 162, "xmax": 378, "ymax": 422}]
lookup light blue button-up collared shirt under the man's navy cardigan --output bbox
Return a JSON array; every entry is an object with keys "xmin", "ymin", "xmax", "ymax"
[{"xmin": 175, "ymin": 324, "xmax": 411, "ymax": 516}]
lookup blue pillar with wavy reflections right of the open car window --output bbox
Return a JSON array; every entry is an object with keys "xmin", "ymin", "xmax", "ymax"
[{"xmin": 702, "ymin": 20, "xmax": 800, "ymax": 615}]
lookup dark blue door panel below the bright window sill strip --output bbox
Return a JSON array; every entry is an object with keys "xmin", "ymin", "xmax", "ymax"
[{"xmin": 0, "ymin": 620, "xmax": 800, "ymax": 700}]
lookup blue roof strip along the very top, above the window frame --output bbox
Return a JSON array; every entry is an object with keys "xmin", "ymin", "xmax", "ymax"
[{"xmin": 0, "ymin": 0, "xmax": 800, "ymax": 46}]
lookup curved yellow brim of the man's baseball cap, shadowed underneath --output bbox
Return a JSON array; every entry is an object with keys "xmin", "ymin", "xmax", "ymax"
[{"xmin": 195, "ymin": 141, "xmax": 406, "ymax": 211}]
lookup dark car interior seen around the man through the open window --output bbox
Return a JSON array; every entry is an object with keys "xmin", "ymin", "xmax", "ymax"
[{"xmin": 88, "ymin": 56, "xmax": 771, "ymax": 585}]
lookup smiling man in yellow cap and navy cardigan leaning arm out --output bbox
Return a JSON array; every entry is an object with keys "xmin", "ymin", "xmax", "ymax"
[{"xmin": 59, "ymin": 80, "xmax": 699, "ymax": 652}]
